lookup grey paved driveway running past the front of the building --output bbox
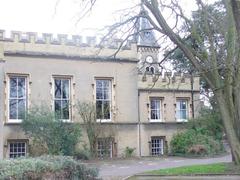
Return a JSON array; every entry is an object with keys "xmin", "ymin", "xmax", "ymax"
[{"xmin": 86, "ymin": 155, "xmax": 231, "ymax": 180}]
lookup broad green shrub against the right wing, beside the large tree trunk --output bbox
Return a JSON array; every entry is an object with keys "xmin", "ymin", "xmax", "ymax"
[{"xmin": 170, "ymin": 109, "xmax": 223, "ymax": 155}]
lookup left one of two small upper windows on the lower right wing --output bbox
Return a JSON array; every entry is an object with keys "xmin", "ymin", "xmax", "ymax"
[{"xmin": 150, "ymin": 98, "xmax": 161, "ymax": 121}]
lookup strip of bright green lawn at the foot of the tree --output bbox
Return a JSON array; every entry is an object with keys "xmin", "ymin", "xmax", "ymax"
[{"xmin": 144, "ymin": 163, "xmax": 240, "ymax": 175}]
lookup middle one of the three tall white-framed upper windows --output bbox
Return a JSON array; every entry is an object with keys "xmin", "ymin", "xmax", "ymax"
[{"xmin": 54, "ymin": 78, "xmax": 70, "ymax": 120}]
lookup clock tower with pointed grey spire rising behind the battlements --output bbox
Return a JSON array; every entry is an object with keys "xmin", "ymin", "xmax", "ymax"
[{"xmin": 136, "ymin": 7, "xmax": 160, "ymax": 74}]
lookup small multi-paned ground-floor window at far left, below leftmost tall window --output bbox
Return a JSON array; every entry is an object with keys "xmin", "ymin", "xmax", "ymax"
[{"xmin": 8, "ymin": 141, "xmax": 27, "ymax": 158}]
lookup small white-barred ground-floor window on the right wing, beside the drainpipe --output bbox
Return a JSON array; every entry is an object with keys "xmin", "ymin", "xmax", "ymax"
[{"xmin": 151, "ymin": 137, "xmax": 164, "ymax": 156}]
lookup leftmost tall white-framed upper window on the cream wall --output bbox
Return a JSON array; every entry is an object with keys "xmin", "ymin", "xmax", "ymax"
[{"xmin": 8, "ymin": 76, "xmax": 27, "ymax": 122}]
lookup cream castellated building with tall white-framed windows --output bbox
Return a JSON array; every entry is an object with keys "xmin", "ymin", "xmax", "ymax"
[{"xmin": 0, "ymin": 26, "xmax": 199, "ymax": 158}]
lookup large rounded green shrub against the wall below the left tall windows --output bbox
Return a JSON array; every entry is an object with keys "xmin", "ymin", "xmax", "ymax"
[{"xmin": 21, "ymin": 106, "xmax": 81, "ymax": 155}]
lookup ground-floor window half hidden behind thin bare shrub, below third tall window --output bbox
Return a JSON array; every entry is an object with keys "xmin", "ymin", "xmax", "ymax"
[{"xmin": 97, "ymin": 138, "xmax": 113, "ymax": 158}]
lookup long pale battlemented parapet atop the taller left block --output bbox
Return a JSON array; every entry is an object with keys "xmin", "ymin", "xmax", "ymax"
[{"xmin": 0, "ymin": 30, "xmax": 137, "ymax": 61}]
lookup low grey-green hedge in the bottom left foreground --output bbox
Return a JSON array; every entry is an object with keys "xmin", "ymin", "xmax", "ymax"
[{"xmin": 0, "ymin": 156, "xmax": 98, "ymax": 180}]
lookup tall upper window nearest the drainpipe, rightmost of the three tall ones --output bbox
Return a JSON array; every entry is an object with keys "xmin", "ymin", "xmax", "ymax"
[{"xmin": 96, "ymin": 79, "xmax": 112, "ymax": 121}]
